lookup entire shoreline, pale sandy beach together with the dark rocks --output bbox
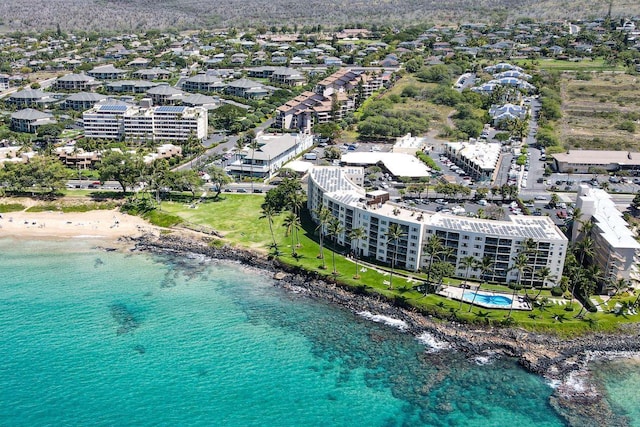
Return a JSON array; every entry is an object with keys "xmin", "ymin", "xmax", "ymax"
[{"xmin": 0, "ymin": 210, "xmax": 640, "ymax": 426}]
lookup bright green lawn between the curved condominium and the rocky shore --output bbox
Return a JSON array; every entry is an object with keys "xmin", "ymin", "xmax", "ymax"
[{"xmin": 162, "ymin": 194, "xmax": 640, "ymax": 336}]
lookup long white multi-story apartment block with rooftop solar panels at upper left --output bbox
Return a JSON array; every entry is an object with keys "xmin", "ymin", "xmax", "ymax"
[{"xmin": 82, "ymin": 105, "xmax": 208, "ymax": 141}]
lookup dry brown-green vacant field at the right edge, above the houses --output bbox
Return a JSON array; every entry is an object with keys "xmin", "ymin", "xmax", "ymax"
[{"xmin": 559, "ymin": 73, "xmax": 640, "ymax": 151}]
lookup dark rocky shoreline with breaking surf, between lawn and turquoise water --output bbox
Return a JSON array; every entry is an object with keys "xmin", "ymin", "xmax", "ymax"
[{"xmin": 129, "ymin": 234, "xmax": 640, "ymax": 426}]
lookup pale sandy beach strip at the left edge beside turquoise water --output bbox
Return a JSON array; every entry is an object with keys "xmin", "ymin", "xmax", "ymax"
[{"xmin": 0, "ymin": 209, "xmax": 157, "ymax": 240}]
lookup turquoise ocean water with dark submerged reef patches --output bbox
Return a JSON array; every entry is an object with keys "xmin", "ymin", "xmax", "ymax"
[{"xmin": 0, "ymin": 239, "xmax": 563, "ymax": 427}]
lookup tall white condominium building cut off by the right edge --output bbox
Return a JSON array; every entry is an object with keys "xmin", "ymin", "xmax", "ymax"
[{"xmin": 571, "ymin": 184, "xmax": 640, "ymax": 284}]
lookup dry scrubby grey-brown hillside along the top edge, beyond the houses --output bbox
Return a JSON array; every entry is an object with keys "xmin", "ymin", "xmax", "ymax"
[{"xmin": 0, "ymin": 0, "xmax": 640, "ymax": 31}]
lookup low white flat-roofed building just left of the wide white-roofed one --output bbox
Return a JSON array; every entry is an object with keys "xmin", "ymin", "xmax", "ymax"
[{"xmin": 226, "ymin": 134, "xmax": 313, "ymax": 178}]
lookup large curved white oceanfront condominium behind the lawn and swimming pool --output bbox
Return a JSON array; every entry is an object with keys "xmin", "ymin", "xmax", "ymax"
[{"xmin": 307, "ymin": 166, "xmax": 567, "ymax": 286}]
